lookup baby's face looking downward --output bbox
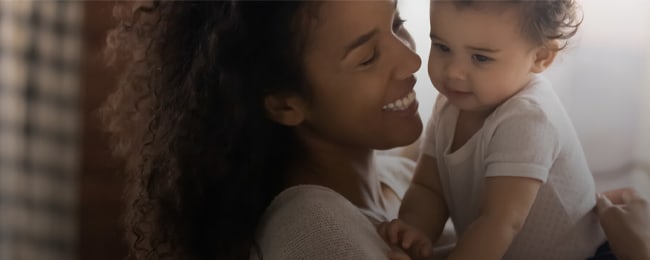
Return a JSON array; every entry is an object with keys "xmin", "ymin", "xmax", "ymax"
[{"xmin": 429, "ymin": 1, "xmax": 541, "ymax": 111}]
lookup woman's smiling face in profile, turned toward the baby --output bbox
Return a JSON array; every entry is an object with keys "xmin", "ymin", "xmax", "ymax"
[{"xmin": 300, "ymin": 0, "xmax": 422, "ymax": 149}]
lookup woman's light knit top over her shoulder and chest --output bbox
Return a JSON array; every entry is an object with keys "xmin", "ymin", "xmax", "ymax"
[{"xmin": 252, "ymin": 156, "xmax": 415, "ymax": 260}]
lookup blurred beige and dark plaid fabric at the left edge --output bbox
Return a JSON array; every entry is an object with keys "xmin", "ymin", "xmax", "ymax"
[{"xmin": 0, "ymin": 0, "xmax": 82, "ymax": 260}]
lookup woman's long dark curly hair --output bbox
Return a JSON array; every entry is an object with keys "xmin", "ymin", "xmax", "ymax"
[{"xmin": 101, "ymin": 0, "xmax": 318, "ymax": 259}]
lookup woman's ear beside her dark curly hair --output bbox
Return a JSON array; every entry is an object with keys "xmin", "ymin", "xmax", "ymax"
[{"xmin": 264, "ymin": 94, "xmax": 306, "ymax": 126}]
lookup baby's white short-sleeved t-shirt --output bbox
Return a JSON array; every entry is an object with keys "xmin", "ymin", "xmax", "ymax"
[{"xmin": 422, "ymin": 76, "xmax": 605, "ymax": 259}]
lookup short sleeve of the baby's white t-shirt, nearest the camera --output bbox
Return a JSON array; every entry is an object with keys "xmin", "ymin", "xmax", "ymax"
[{"xmin": 485, "ymin": 101, "xmax": 560, "ymax": 183}]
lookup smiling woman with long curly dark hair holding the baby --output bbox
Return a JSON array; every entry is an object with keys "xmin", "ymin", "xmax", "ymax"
[{"xmin": 104, "ymin": 0, "xmax": 648, "ymax": 259}]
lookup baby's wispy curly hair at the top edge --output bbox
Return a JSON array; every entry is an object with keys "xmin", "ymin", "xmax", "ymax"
[{"xmin": 448, "ymin": 0, "xmax": 583, "ymax": 50}]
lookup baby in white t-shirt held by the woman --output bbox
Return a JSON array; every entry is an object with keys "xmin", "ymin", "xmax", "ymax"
[{"xmin": 379, "ymin": 0, "xmax": 605, "ymax": 259}]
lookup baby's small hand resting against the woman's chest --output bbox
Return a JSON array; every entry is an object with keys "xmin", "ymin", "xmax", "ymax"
[{"xmin": 377, "ymin": 219, "xmax": 433, "ymax": 259}]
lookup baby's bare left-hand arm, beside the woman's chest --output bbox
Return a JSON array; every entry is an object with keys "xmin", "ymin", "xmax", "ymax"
[{"xmin": 399, "ymin": 154, "xmax": 449, "ymax": 246}]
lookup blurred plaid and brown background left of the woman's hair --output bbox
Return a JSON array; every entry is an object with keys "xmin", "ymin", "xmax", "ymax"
[{"xmin": 0, "ymin": 0, "xmax": 126, "ymax": 260}]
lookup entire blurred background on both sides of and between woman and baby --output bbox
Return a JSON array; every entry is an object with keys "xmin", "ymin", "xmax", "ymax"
[{"xmin": 0, "ymin": 0, "xmax": 650, "ymax": 260}]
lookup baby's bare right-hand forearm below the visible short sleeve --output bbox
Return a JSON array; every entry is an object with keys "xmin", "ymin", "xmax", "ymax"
[{"xmin": 448, "ymin": 177, "xmax": 542, "ymax": 259}]
